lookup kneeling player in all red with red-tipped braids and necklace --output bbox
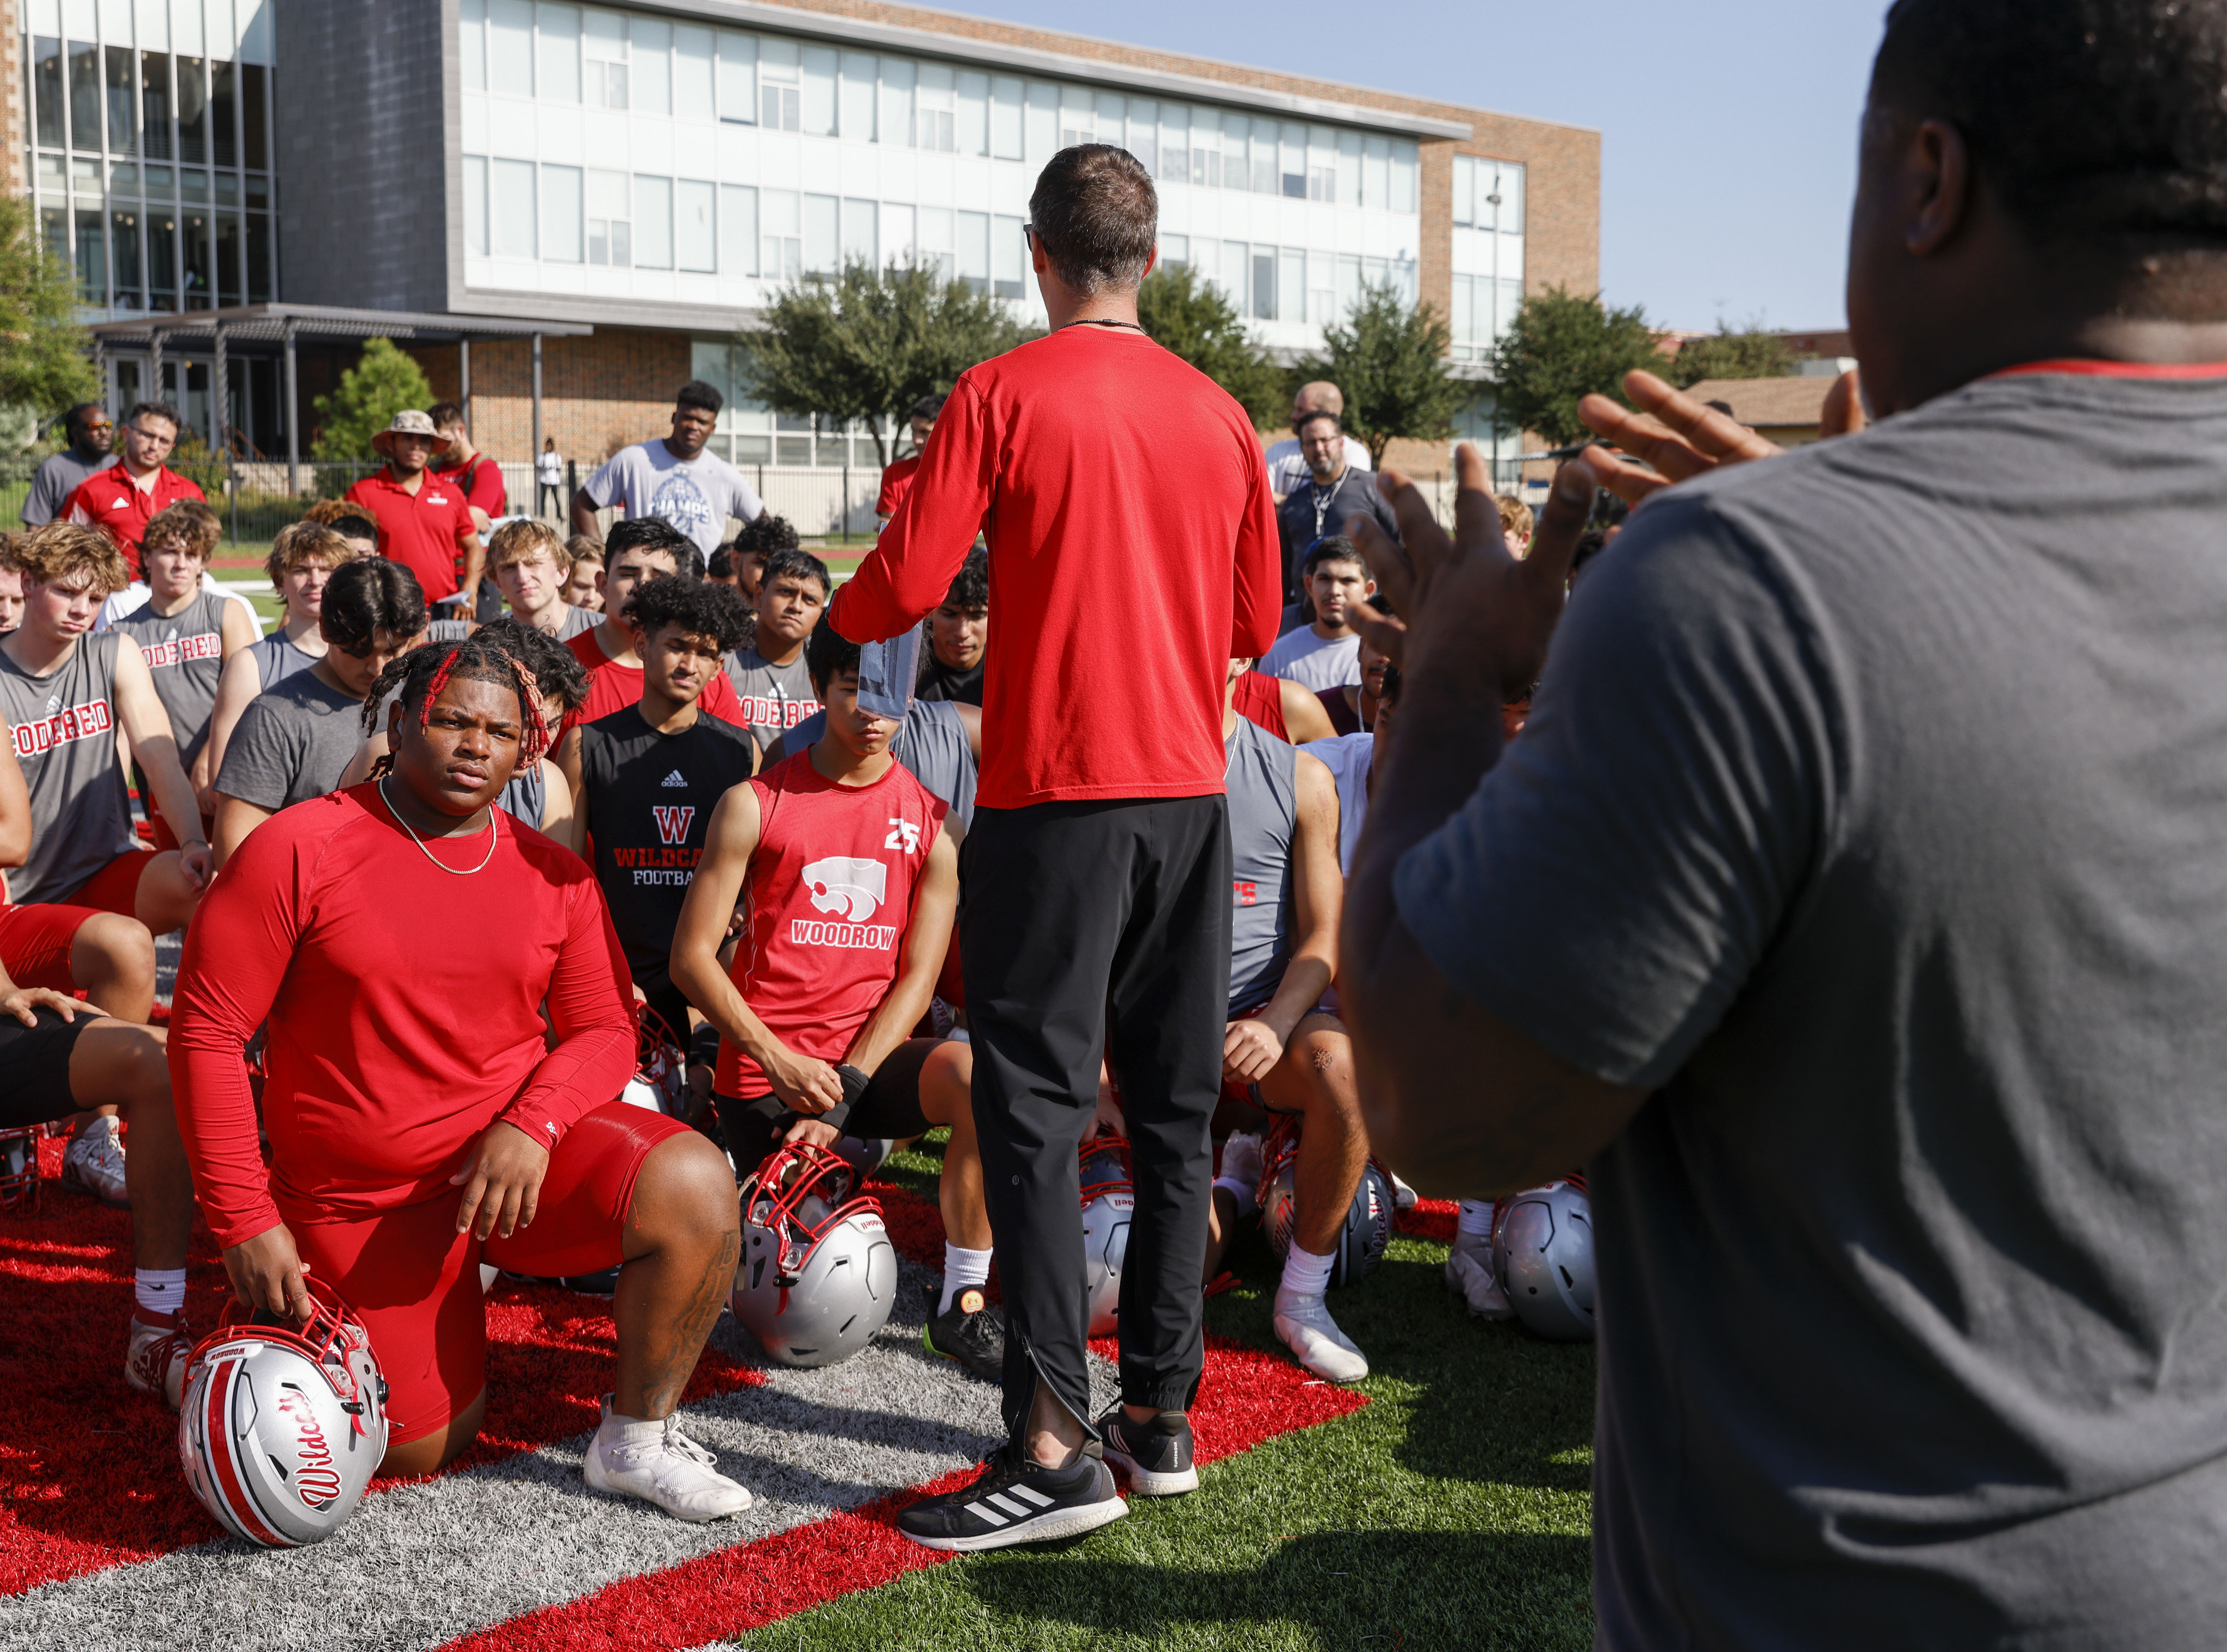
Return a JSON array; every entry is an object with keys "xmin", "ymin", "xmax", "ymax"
[{"xmin": 171, "ymin": 641, "xmax": 750, "ymax": 1520}]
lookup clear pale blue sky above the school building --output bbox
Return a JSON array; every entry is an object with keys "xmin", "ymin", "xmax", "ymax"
[{"xmin": 913, "ymin": 0, "xmax": 1886, "ymax": 330}]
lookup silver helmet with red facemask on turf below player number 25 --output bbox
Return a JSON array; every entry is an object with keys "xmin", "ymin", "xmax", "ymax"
[{"xmin": 728, "ymin": 1142, "xmax": 898, "ymax": 1365}]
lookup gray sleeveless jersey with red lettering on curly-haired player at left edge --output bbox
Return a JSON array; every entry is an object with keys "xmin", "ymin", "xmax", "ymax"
[{"xmin": 0, "ymin": 630, "xmax": 138, "ymax": 906}]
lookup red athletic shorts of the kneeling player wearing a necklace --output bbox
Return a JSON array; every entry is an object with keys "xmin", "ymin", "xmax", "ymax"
[{"xmin": 278, "ymin": 1102, "xmax": 688, "ymax": 1445}]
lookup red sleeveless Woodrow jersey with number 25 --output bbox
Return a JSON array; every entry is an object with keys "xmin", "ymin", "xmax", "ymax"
[{"xmin": 715, "ymin": 750, "xmax": 944, "ymax": 1100}]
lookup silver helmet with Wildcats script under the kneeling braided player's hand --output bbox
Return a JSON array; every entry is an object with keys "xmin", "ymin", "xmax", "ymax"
[{"xmin": 178, "ymin": 1278, "xmax": 388, "ymax": 1550}]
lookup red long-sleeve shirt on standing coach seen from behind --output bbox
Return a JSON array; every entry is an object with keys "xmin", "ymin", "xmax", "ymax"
[{"xmin": 826, "ymin": 325, "xmax": 1283, "ymax": 808}]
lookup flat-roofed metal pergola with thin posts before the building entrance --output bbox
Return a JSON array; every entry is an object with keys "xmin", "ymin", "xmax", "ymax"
[{"xmin": 87, "ymin": 305, "xmax": 595, "ymax": 492}]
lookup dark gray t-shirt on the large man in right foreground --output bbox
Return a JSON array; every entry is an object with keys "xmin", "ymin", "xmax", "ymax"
[{"xmin": 1396, "ymin": 370, "xmax": 2227, "ymax": 1652}]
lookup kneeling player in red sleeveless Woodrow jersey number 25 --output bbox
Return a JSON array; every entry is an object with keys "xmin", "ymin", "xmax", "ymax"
[{"xmin": 673, "ymin": 626, "xmax": 1004, "ymax": 1380}]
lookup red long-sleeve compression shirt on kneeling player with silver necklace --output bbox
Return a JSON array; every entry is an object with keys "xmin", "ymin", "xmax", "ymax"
[{"xmin": 169, "ymin": 786, "xmax": 634, "ymax": 1245}]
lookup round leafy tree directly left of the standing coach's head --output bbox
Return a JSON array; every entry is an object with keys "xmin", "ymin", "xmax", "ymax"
[{"xmin": 735, "ymin": 258, "xmax": 1027, "ymax": 465}]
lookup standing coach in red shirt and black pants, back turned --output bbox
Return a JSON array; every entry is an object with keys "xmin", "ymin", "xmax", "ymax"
[{"xmin": 829, "ymin": 142, "xmax": 1280, "ymax": 1550}]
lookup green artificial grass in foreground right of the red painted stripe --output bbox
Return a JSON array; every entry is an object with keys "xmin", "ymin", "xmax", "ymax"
[{"xmin": 744, "ymin": 1135, "xmax": 1593, "ymax": 1652}]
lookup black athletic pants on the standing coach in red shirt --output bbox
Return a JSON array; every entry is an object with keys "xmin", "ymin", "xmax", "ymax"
[{"xmin": 960, "ymin": 795, "xmax": 1229, "ymax": 1440}]
